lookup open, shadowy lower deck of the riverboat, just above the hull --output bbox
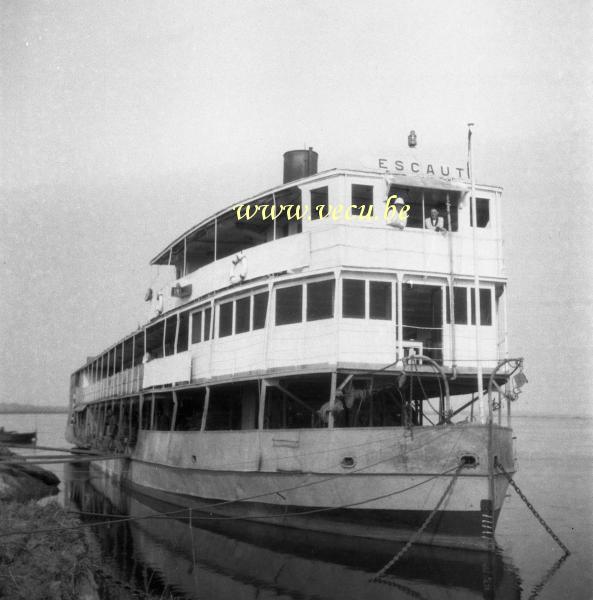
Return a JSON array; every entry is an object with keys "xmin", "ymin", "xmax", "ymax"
[{"xmin": 68, "ymin": 357, "xmax": 514, "ymax": 454}]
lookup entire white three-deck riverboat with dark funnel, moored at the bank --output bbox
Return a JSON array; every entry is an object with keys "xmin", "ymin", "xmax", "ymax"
[{"xmin": 67, "ymin": 139, "xmax": 525, "ymax": 549}]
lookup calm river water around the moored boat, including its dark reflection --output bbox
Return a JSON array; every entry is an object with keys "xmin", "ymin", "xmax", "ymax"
[{"xmin": 0, "ymin": 415, "xmax": 593, "ymax": 600}]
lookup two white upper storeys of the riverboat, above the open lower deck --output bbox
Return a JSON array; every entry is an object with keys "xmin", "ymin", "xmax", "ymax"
[{"xmin": 68, "ymin": 155, "xmax": 506, "ymax": 410}]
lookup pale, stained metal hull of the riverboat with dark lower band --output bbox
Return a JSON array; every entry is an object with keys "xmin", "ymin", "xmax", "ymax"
[{"xmin": 84, "ymin": 425, "xmax": 514, "ymax": 550}]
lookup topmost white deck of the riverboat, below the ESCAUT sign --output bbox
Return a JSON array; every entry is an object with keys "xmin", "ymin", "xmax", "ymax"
[{"xmin": 151, "ymin": 169, "xmax": 504, "ymax": 316}]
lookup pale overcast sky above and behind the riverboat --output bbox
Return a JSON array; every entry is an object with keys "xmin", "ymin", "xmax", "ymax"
[{"xmin": 0, "ymin": 0, "xmax": 593, "ymax": 414}]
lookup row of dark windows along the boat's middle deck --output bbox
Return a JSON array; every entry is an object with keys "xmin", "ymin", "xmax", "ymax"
[{"xmin": 80, "ymin": 278, "xmax": 492, "ymax": 381}]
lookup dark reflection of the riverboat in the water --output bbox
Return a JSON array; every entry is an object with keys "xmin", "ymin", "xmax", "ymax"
[{"xmin": 66, "ymin": 467, "xmax": 520, "ymax": 600}]
